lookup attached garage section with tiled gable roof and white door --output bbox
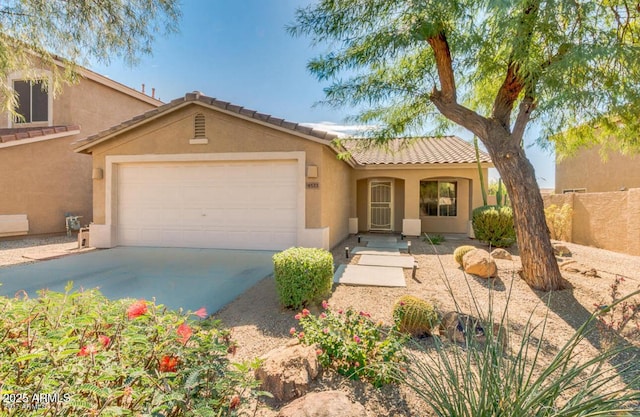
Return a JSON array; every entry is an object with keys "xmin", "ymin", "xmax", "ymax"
[{"xmin": 74, "ymin": 93, "xmax": 351, "ymax": 251}]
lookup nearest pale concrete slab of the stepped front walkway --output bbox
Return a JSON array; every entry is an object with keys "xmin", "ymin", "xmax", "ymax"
[{"xmin": 333, "ymin": 265, "xmax": 407, "ymax": 287}]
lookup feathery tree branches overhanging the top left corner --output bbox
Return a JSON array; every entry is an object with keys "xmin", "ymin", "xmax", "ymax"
[{"xmin": 0, "ymin": 0, "xmax": 180, "ymax": 111}]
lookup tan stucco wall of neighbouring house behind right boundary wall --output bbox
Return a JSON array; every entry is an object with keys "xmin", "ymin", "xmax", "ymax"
[{"xmin": 556, "ymin": 147, "xmax": 640, "ymax": 194}]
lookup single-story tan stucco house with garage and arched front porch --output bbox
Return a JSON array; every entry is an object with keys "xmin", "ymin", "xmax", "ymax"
[{"xmin": 74, "ymin": 92, "xmax": 491, "ymax": 250}]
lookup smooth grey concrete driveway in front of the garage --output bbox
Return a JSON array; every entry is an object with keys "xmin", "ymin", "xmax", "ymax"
[{"xmin": 0, "ymin": 247, "xmax": 274, "ymax": 313}]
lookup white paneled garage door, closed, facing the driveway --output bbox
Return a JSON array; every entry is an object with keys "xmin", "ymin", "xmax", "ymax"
[{"xmin": 116, "ymin": 161, "xmax": 298, "ymax": 250}]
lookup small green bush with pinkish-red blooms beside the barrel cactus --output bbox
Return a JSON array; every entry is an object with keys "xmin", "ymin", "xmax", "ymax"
[{"xmin": 291, "ymin": 302, "xmax": 406, "ymax": 386}]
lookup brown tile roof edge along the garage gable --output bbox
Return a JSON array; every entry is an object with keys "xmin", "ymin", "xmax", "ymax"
[{"xmin": 74, "ymin": 92, "xmax": 338, "ymax": 152}]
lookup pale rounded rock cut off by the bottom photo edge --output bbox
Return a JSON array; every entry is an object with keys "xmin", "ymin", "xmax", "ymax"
[{"xmin": 278, "ymin": 391, "xmax": 367, "ymax": 417}]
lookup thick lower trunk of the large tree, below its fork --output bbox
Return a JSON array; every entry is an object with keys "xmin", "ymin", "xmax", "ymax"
[{"xmin": 483, "ymin": 129, "xmax": 563, "ymax": 291}]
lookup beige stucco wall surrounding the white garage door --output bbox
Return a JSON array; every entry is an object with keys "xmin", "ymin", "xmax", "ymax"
[{"xmin": 92, "ymin": 104, "xmax": 342, "ymax": 245}]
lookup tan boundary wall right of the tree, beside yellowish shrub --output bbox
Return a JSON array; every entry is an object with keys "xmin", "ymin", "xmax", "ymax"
[{"xmin": 543, "ymin": 188, "xmax": 640, "ymax": 255}]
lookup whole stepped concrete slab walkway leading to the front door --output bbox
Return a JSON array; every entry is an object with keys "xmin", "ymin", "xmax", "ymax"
[{"xmin": 333, "ymin": 235, "xmax": 415, "ymax": 287}]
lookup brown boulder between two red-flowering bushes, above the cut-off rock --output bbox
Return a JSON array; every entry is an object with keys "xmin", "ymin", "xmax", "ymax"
[{"xmin": 255, "ymin": 344, "xmax": 319, "ymax": 401}]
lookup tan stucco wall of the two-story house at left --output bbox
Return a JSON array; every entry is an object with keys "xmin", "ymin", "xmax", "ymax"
[{"xmin": 0, "ymin": 73, "xmax": 154, "ymax": 234}]
